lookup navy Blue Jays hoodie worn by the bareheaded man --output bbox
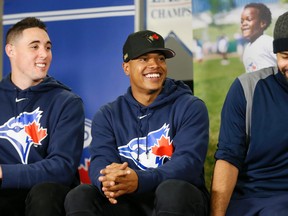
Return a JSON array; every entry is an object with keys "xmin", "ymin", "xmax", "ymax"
[{"xmin": 0, "ymin": 74, "xmax": 84, "ymax": 188}]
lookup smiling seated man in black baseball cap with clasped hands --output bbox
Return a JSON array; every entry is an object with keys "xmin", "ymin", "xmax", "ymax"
[{"xmin": 65, "ymin": 30, "xmax": 209, "ymax": 216}]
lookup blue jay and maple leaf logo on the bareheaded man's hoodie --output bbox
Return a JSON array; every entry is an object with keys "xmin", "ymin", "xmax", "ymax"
[{"xmin": 0, "ymin": 107, "xmax": 47, "ymax": 164}]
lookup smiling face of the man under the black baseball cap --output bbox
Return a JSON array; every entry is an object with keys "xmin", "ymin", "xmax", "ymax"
[{"xmin": 123, "ymin": 53, "xmax": 167, "ymax": 105}]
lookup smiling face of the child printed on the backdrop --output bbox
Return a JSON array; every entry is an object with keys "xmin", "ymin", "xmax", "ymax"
[{"xmin": 241, "ymin": 7, "xmax": 267, "ymax": 43}]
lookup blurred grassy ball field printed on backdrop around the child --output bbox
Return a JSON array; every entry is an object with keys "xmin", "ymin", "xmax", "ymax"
[{"xmin": 192, "ymin": 0, "xmax": 288, "ymax": 188}]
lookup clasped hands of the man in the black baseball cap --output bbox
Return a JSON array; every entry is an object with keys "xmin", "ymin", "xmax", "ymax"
[{"xmin": 98, "ymin": 162, "xmax": 138, "ymax": 204}]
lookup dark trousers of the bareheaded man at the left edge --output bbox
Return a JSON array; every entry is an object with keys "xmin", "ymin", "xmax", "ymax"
[{"xmin": 0, "ymin": 183, "xmax": 70, "ymax": 216}]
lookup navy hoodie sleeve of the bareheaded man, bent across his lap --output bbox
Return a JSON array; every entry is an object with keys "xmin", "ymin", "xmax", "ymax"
[{"xmin": 1, "ymin": 95, "xmax": 84, "ymax": 188}]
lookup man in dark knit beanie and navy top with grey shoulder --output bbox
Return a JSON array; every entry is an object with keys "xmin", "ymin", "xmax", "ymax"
[{"xmin": 211, "ymin": 12, "xmax": 288, "ymax": 216}]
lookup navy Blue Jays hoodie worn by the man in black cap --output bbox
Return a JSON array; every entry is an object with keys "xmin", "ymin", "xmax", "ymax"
[{"xmin": 89, "ymin": 79, "xmax": 209, "ymax": 193}]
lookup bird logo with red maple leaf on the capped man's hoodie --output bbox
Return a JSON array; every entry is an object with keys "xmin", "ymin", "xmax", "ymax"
[{"xmin": 118, "ymin": 124, "xmax": 174, "ymax": 170}]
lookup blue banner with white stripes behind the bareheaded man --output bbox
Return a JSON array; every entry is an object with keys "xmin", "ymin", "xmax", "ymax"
[{"xmin": 3, "ymin": 0, "xmax": 135, "ymax": 183}]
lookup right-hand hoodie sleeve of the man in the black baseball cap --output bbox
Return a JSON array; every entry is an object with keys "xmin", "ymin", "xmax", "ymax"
[{"xmin": 136, "ymin": 98, "xmax": 209, "ymax": 193}]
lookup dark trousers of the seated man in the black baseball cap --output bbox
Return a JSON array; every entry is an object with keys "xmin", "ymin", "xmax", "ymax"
[{"xmin": 65, "ymin": 180, "xmax": 209, "ymax": 216}]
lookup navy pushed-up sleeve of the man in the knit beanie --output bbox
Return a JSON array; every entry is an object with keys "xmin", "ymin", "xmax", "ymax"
[{"xmin": 215, "ymin": 79, "xmax": 247, "ymax": 169}]
